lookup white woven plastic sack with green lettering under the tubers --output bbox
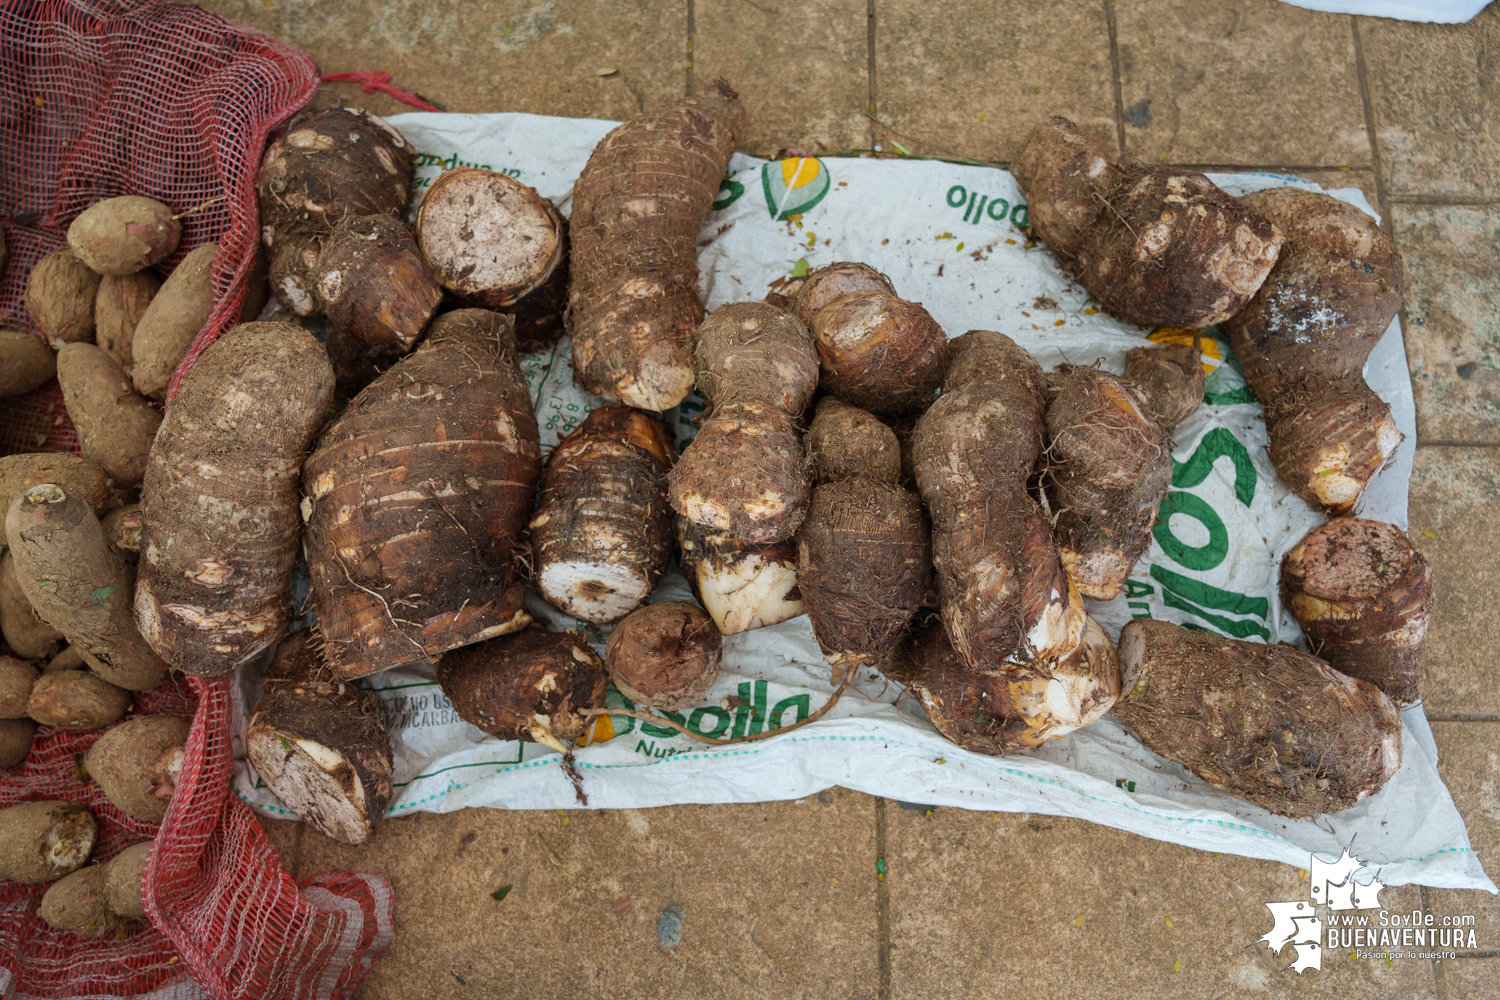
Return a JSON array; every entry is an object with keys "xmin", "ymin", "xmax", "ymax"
[{"xmin": 236, "ymin": 114, "xmax": 1494, "ymax": 891}]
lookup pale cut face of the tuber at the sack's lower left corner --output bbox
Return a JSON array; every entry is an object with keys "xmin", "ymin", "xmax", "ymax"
[{"xmin": 246, "ymin": 730, "xmax": 374, "ymax": 844}]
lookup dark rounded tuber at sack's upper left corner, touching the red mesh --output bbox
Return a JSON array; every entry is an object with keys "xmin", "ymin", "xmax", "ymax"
[{"xmin": 255, "ymin": 108, "xmax": 417, "ymax": 238}]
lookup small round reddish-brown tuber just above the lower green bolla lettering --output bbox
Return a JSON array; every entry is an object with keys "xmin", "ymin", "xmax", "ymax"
[{"xmin": 605, "ymin": 601, "xmax": 723, "ymax": 712}]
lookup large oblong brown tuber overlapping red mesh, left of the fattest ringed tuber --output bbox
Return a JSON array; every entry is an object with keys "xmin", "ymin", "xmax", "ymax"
[{"xmin": 135, "ymin": 325, "xmax": 333, "ymax": 676}]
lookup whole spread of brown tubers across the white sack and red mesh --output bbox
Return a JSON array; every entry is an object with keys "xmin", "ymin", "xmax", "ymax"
[{"xmin": 0, "ymin": 81, "xmax": 1433, "ymax": 933}]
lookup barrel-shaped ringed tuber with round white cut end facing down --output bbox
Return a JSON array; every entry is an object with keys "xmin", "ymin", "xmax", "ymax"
[{"xmin": 531, "ymin": 406, "xmax": 677, "ymax": 622}]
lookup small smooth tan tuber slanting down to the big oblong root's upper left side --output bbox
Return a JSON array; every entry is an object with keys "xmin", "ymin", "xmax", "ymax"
[{"xmin": 57, "ymin": 343, "xmax": 162, "ymax": 489}]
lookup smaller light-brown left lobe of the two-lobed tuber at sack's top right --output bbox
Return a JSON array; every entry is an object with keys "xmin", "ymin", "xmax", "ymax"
[{"xmin": 1011, "ymin": 117, "xmax": 1121, "ymax": 261}]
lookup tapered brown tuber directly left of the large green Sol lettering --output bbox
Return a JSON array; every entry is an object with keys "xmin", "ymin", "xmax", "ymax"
[{"xmin": 1044, "ymin": 364, "xmax": 1172, "ymax": 601}]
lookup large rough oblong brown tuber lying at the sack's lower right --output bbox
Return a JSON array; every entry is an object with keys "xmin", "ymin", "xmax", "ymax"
[{"xmin": 1115, "ymin": 618, "xmax": 1401, "ymax": 819}]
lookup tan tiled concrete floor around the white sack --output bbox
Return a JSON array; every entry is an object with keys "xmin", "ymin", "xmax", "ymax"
[{"xmin": 206, "ymin": 0, "xmax": 1500, "ymax": 1000}]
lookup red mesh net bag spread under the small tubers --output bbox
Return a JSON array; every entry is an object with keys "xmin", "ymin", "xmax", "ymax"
[{"xmin": 0, "ymin": 0, "xmax": 393, "ymax": 1000}]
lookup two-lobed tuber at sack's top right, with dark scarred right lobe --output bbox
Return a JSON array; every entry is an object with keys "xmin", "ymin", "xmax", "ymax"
[{"xmin": 1016, "ymin": 118, "xmax": 1283, "ymax": 328}]
